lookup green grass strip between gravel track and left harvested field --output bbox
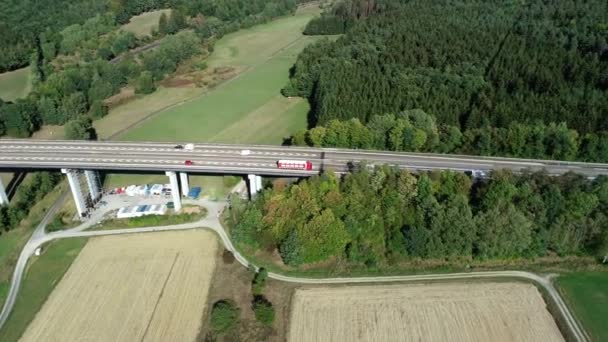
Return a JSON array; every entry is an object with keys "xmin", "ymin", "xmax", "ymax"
[{"xmin": 0, "ymin": 238, "xmax": 87, "ymax": 342}]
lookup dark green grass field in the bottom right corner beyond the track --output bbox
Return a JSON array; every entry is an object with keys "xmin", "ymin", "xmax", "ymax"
[{"xmin": 557, "ymin": 272, "xmax": 608, "ymax": 342}]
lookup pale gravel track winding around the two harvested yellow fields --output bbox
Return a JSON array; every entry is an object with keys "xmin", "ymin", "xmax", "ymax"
[{"xmin": 0, "ymin": 195, "xmax": 588, "ymax": 342}]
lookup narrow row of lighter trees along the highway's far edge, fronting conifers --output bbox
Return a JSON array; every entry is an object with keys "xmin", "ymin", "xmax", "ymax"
[{"xmin": 287, "ymin": 110, "xmax": 608, "ymax": 163}]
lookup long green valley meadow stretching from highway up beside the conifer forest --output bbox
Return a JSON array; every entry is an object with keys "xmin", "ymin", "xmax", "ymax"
[{"xmin": 120, "ymin": 9, "xmax": 319, "ymax": 144}]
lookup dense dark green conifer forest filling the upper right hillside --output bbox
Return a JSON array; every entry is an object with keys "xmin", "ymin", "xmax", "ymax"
[{"xmin": 284, "ymin": 0, "xmax": 608, "ymax": 136}]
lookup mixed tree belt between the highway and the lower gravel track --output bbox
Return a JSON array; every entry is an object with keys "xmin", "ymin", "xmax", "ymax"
[{"xmin": 231, "ymin": 170, "xmax": 608, "ymax": 266}]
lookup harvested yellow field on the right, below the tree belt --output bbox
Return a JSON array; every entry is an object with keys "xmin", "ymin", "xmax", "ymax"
[{"xmin": 288, "ymin": 283, "xmax": 564, "ymax": 342}]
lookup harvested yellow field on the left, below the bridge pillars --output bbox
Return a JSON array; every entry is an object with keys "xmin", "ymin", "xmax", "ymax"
[{"xmin": 21, "ymin": 230, "xmax": 217, "ymax": 342}]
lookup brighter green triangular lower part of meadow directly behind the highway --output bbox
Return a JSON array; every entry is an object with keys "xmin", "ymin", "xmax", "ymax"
[{"xmin": 120, "ymin": 39, "xmax": 312, "ymax": 144}]
